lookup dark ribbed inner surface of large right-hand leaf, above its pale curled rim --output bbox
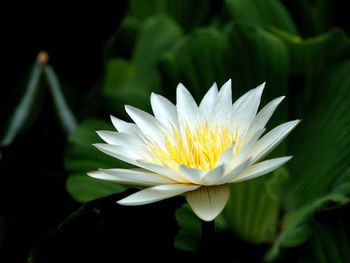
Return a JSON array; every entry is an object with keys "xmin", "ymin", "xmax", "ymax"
[{"xmin": 284, "ymin": 60, "xmax": 350, "ymax": 210}]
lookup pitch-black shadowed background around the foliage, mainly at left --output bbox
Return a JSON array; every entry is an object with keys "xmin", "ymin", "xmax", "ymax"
[{"xmin": 0, "ymin": 1, "xmax": 350, "ymax": 262}]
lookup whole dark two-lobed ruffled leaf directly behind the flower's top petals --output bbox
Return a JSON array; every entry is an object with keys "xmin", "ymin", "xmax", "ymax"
[{"xmin": 160, "ymin": 24, "xmax": 289, "ymax": 125}]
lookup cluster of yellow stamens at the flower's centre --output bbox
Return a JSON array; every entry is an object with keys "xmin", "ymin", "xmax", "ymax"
[{"xmin": 148, "ymin": 122, "xmax": 237, "ymax": 171}]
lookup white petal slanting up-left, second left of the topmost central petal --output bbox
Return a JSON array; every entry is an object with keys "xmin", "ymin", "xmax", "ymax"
[{"xmin": 125, "ymin": 105, "xmax": 166, "ymax": 151}]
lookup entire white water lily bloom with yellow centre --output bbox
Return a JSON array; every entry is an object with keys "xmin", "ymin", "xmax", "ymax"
[{"xmin": 88, "ymin": 80, "xmax": 299, "ymax": 221}]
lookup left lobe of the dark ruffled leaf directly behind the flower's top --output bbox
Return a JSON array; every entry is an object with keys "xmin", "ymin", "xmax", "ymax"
[{"xmin": 161, "ymin": 28, "xmax": 232, "ymax": 101}]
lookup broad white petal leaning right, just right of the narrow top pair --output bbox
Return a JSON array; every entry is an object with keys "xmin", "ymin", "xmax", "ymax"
[{"xmin": 231, "ymin": 82, "xmax": 265, "ymax": 134}]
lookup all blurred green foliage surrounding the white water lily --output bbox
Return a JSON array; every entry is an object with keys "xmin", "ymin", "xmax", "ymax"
[{"xmin": 0, "ymin": 0, "xmax": 350, "ymax": 262}]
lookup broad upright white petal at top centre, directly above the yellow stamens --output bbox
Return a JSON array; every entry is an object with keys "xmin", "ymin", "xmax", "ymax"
[{"xmin": 176, "ymin": 83, "xmax": 200, "ymax": 131}]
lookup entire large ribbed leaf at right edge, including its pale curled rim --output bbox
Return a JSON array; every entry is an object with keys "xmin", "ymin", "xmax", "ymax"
[{"xmin": 268, "ymin": 60, "xmax": 350, "ymax": 260}]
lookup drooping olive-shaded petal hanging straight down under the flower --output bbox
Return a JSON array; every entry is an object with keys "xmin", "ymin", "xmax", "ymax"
[{"xmin": 186, "ymin": 185, "xmax": 230, "ymax": 221}]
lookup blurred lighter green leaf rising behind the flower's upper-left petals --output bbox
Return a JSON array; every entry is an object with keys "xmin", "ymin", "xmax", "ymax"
[{"xmin": 102, "ymin": 16, "xmax": 181, "ymax": 114}]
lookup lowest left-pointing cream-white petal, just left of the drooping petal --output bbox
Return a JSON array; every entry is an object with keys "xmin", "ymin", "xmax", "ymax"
[{"xmin": 117, "ymin": 184, "xmax": 199, "ymax": 205}]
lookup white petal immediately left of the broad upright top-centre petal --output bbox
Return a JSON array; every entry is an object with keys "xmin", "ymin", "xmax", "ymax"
[{"xmin": 151, "ymin": 93, "xmax": 179, "ymax": 131}]
